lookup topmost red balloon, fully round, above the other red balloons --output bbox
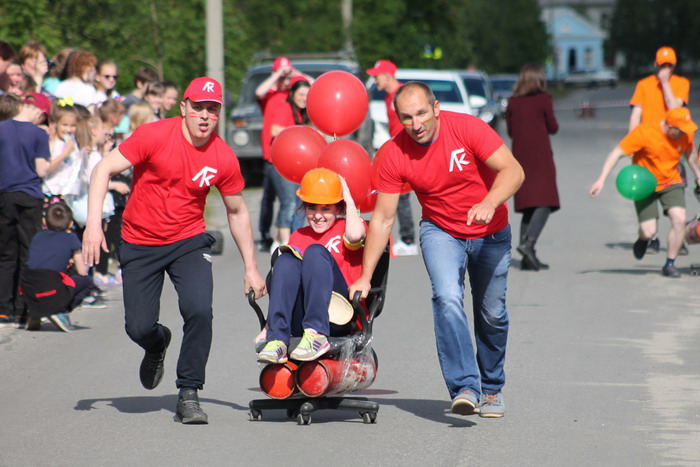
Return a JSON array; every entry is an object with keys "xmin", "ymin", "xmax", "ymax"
[{"xmin": 306, "ymin": 70, "xmax": 369, "ymax": 136}]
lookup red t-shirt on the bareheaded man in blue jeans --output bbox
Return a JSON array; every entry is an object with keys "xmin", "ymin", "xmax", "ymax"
[{"xmin": 377, "ymin": 111, "xmax": 508, "ymax": 238}]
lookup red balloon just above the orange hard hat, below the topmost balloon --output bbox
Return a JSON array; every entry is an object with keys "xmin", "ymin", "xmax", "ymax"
[{"xmin": 318, "ymin": 139, "xmax": 372, "ymax": 205}]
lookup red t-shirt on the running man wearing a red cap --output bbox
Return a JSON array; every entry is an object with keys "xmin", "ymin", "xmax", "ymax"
[{"xmin": 119, "ymin": 117, "xmax": 245, "ymax": 245}]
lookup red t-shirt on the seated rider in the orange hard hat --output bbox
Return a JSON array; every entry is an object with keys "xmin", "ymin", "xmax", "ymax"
[{"xmin": 288, "ymin": 219, "xmax": 363, "ymax": 286}]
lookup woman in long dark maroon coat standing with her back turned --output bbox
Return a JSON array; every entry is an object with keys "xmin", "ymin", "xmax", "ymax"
[{"xmin": 506, "ymin": 64, "xmax": 559, "ymax": 271}]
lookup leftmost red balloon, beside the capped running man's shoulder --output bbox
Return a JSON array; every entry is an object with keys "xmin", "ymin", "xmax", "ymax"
[{"xmin": 270, "ymin": 125, "xmax": 327, "ymax": 183}]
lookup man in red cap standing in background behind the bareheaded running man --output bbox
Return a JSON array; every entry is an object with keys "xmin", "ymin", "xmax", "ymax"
[{"xmin": 367, "ymin": 60, "xmax": 418, "ymax": 256}]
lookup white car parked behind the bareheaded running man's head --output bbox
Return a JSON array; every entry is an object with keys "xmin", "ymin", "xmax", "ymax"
[{"xmin": 367, "ymin": 68, "xmax": 477, "ymax": 149}]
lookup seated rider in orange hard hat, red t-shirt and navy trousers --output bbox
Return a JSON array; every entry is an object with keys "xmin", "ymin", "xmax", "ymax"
[{"xmin": 256, "ymin": 169, "xmax": 366, "ymax": 363}]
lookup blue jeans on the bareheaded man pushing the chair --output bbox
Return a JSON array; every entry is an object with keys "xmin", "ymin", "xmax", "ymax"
[{"xmin": 420, "ymin": 220, "xmax": 511, "ymax": 398}]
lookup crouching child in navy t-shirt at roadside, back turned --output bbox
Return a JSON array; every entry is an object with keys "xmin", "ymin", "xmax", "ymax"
[{"xmin": 21, "ymin": 203, "xmax": 93, "ymax": 332}]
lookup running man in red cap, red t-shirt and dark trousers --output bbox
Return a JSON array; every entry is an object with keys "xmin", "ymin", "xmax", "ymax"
[{"xmin": 83, "ymin": 77, "xmax": 266, "ymax": 424}]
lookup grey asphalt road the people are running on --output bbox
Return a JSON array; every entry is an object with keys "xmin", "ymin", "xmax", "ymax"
[{"xmin": 0, "ymin": 82, "xmax": 700, "ymax": 466}]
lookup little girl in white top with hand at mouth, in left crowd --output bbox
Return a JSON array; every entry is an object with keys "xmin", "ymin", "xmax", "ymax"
[{"xmin": 44, "ymin": 99, "xmax": 82, "ymax": 195}]
